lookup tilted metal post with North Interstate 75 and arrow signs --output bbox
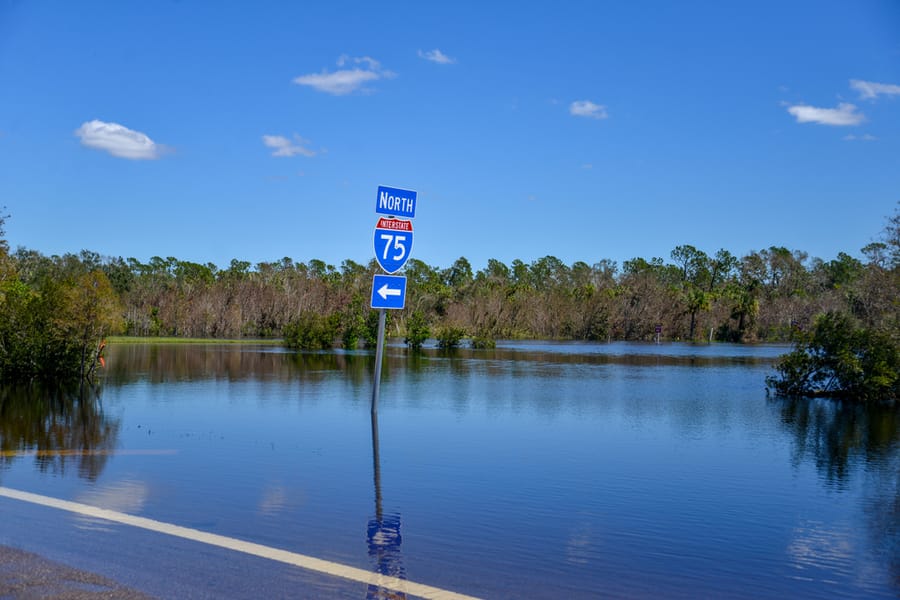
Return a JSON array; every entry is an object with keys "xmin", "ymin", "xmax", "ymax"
[{"xmin": 371, "ymin": 186, "xmax": 417, "ymax": 419}]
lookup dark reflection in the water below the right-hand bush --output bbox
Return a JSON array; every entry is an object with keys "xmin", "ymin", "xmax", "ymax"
[{"xmin": 773, "ymin": 398, "xmax": 900, "ymax": 589}]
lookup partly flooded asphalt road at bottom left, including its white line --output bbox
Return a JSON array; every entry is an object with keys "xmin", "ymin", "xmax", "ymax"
[{"xmin": 0, "ymin": 486, "xmax": 478, "ymax": 600}]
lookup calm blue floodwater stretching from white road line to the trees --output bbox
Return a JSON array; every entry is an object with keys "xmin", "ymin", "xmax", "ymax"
[{"xmin": 0, "ymin": 342, "xmax": 900, "ymax": 598}]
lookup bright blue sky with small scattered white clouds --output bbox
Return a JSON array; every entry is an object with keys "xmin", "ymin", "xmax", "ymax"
[{"xmin": 0, "ymin": 0, "xmax": 900, "ymax": 269}]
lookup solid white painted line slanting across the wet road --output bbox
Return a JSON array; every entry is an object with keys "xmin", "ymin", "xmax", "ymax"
[{"xmin": 0, "ymin": 487, "xmax": 474, "ymax": 600}]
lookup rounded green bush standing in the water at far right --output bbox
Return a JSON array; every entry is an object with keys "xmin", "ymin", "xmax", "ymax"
[{"xmin": 766, "ymin": 312, "xmax": 900, "ymax": 404}]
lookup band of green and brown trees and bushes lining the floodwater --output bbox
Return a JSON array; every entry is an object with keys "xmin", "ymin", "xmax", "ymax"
[{"xmin": 0, "ymin": 210, "xmax": 900, "ymax": 401}]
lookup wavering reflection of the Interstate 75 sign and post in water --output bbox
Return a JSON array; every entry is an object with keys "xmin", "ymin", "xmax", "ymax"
[{"xmin": 366, "ymin": 411, "xmax": 406, "ymax": 600}]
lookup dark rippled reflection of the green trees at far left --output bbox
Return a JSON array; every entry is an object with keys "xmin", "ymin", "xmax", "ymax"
[{"xmin": 0, "ymin": 386, "xmax": 120, "ymax": 481}]
